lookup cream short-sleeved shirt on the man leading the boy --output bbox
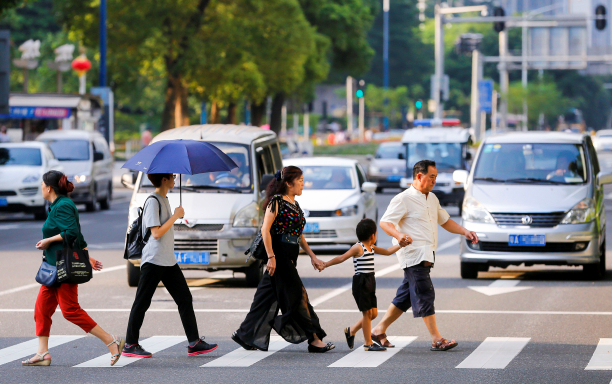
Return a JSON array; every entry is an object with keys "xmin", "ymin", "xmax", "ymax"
[{"xmin": 380, "ymin": 186, "xmax": 450, "ymax": 268}]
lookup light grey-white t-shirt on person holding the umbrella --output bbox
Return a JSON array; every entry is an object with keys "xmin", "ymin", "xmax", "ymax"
[{"xmin": 140, "ymin": 192, "xmax": 176, "ymax": 267}]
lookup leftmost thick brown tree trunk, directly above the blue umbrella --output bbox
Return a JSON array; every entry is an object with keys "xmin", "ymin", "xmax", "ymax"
[{"xmin": 161, "ymin": 74, "xmax": 189, "ymax": 131}]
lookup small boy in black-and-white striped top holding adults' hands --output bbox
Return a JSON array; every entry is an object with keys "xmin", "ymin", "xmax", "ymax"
[{"xmin": 321, "ymin": 219, "xmax": 407, "ymax": 352}]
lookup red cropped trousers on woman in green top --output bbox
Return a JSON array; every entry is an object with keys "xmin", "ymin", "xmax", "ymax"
[{"xmin": 34, "ymin": 284, "xmax": 97, "ymax": 337}]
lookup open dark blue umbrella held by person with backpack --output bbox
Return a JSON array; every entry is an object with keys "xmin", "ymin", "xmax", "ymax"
[{"xmin": 121, "ymin": 140, "xmax": 238, "ymax": 205}]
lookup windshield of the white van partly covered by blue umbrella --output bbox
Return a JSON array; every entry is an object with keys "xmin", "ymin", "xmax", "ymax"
[{"xmin": 140, "ymin": 143, "xmax": 253, "ymax": 193}]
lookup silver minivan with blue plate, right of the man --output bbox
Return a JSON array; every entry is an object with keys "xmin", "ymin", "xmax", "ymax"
[{"xmin": 453, "ymin": 132, "xmax": 612, "ymax": 278}]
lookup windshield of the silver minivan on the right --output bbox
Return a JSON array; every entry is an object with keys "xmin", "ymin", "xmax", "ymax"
[{"xmin": 474, "ymin": 144, "xmax": 587, "ymax": 184}]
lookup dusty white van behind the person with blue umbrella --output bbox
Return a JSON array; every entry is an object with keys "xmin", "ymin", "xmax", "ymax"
[{"xmin": 122, "ymin": 125, "xmax": 283, "ymax": 287}]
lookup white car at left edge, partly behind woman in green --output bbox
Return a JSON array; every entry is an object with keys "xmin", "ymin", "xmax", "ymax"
[{"xmin": 0, "ymin": 141, "xmax": 63, "ymax": 220}]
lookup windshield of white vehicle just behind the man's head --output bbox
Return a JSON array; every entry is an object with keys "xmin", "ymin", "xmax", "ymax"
[{"xmin": 407, "ymin": 143, "xmax": 464, "ymax": 169}]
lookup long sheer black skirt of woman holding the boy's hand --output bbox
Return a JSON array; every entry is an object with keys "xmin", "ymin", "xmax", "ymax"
[{"xmin": 238, "ymin": 237, "xmax": 327, "ymax": 351}]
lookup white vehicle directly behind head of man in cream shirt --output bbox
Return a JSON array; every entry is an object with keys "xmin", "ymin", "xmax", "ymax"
[{"xmin": 400, "ymin": 128, "xmax": 472, "ymax": 215}]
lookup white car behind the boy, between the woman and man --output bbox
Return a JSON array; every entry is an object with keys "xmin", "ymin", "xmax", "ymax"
[{"xmin": 283, "ymin": 157, "xmax": 378, "ymax": 245}]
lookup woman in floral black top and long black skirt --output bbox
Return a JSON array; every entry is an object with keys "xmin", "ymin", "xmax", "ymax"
[{"xmin": 232, "ymin": 166, "xmax": 335, "ymax": 353}]
